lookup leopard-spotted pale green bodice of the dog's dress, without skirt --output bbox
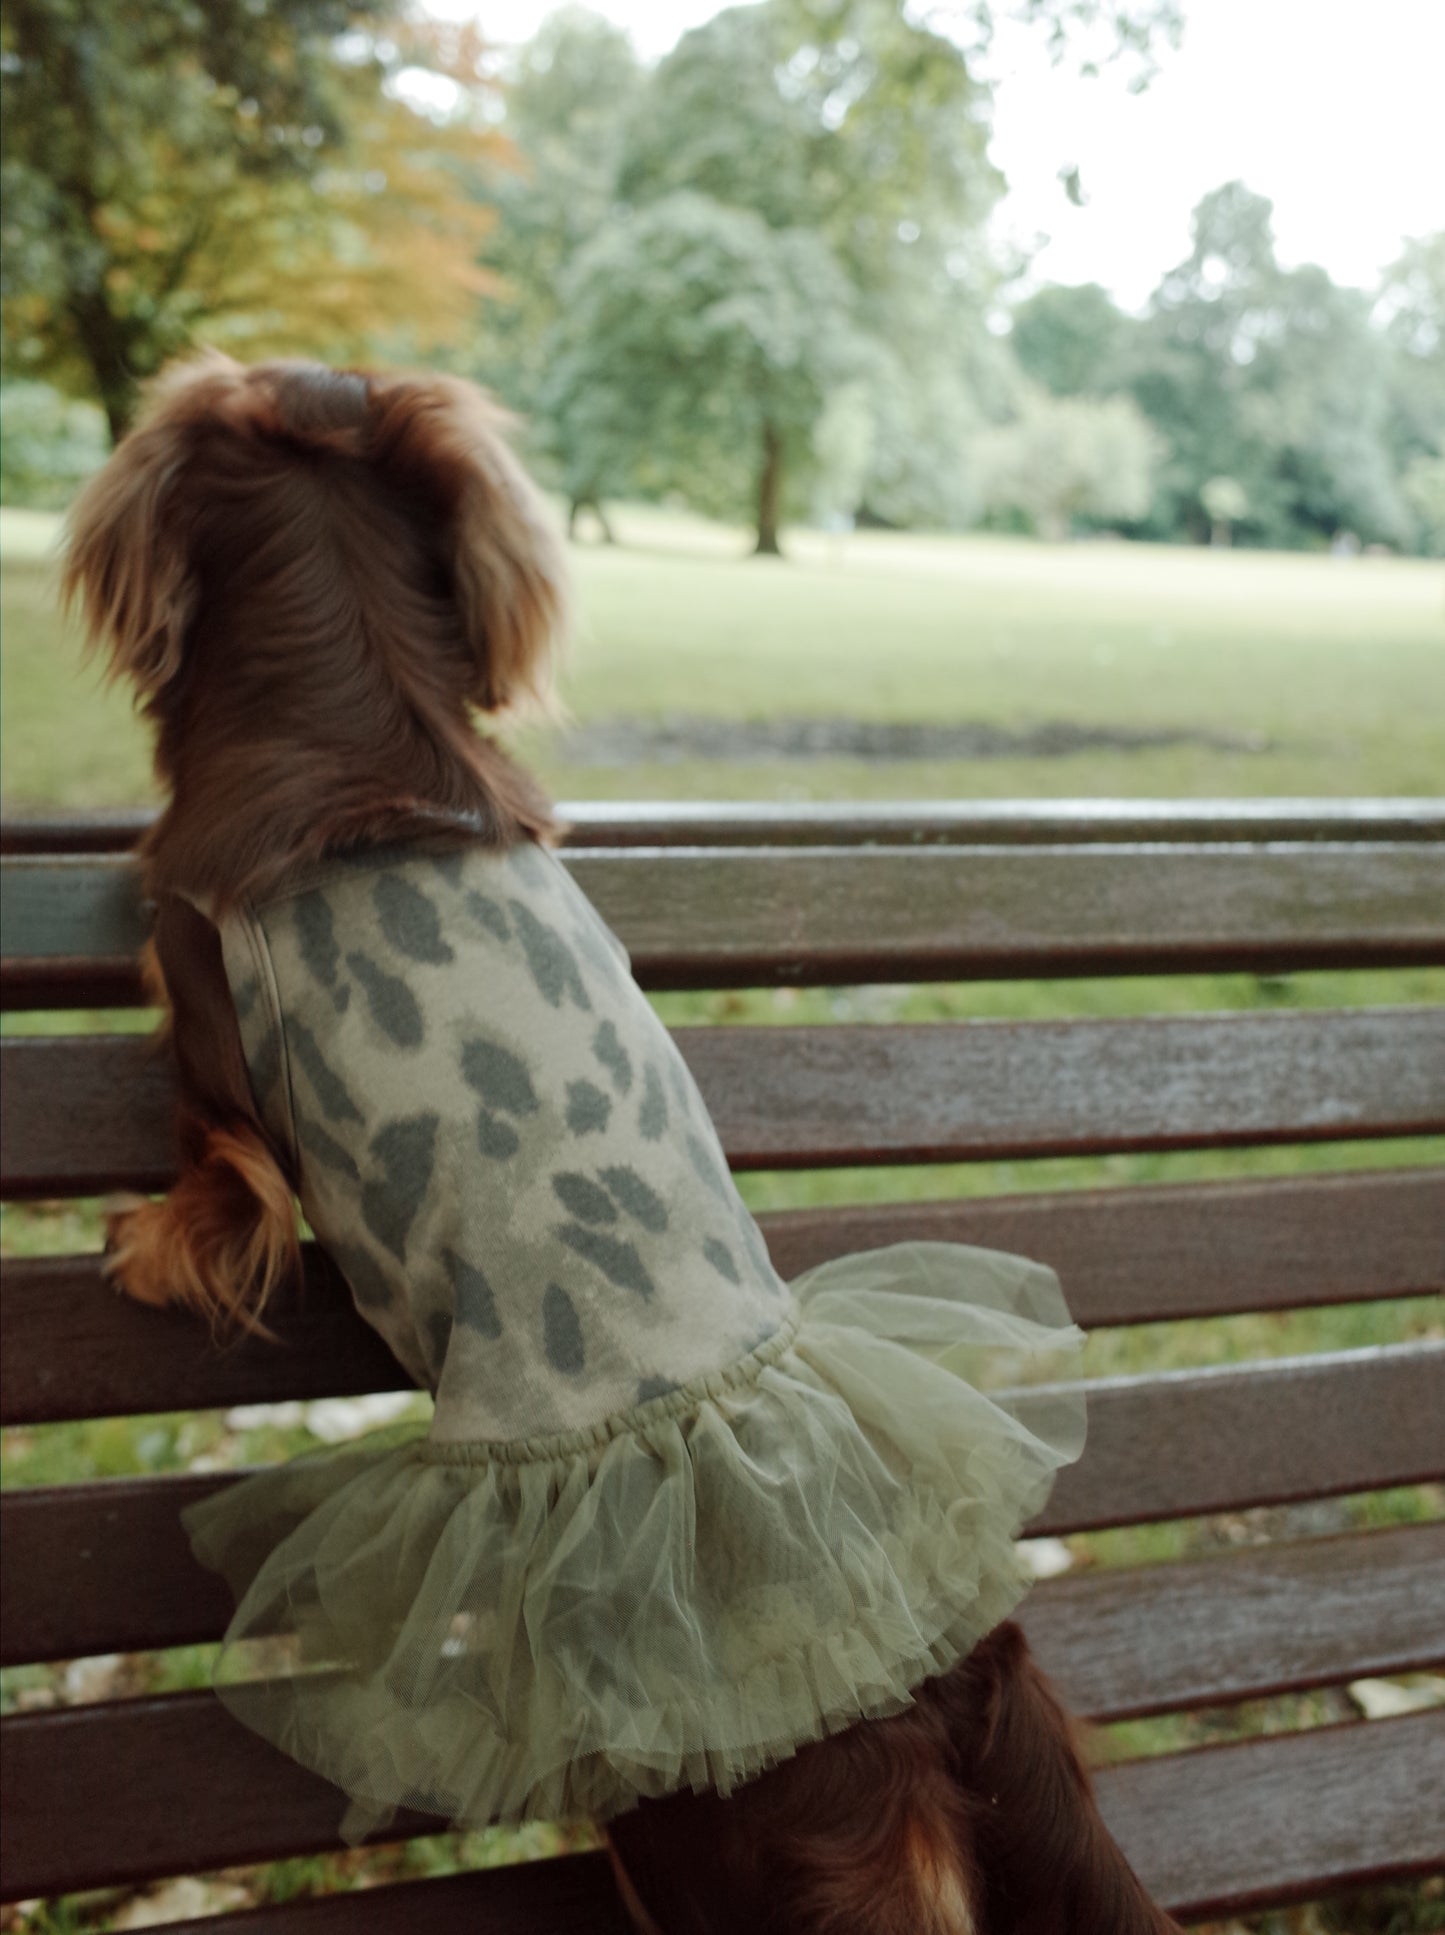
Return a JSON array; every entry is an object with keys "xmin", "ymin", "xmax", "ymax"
[{"xmin": 222, "ymin": 842, "xmax": 787, "ymax": 1444}]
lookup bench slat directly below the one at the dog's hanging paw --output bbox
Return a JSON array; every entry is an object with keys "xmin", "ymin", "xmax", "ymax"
[{"xmin": 0, "ymin": 1343, "xmax": 1445, "ymax": 1664}]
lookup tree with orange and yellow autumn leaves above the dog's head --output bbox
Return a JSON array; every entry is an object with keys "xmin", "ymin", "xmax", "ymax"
[{"xmin": 0, "ymin": 0, "xmax": 497, "ymax": 435}]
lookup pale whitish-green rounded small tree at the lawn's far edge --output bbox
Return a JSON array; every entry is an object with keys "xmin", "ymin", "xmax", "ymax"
[{"xmin": 975, "ymin": 393, "xmax": 1155, "ymax": 544}]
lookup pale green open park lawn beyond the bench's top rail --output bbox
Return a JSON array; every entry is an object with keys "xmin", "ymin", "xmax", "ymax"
[{"xmin": 0, "ymin": 507, "xmax": 1445, "ymax": 807}]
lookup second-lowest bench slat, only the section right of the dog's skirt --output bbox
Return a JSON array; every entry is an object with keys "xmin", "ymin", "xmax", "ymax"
[{"xmin": 1019, "ymin": 1525, "xmax": 1445, "ymax": 1720}]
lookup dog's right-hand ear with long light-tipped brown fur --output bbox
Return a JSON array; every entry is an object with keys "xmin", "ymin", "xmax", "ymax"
[{"xmin": 369, "ymin": 375, "xmax": 567, "ymax": 712}]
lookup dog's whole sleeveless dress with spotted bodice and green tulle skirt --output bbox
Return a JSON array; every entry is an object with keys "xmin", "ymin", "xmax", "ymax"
[{"xmin": 186, "ymin": 842, "xmax": 1083, "ymax": 1834}]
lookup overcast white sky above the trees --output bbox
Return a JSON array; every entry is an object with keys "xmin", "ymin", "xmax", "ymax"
[{"xmin": 437, "ymin": 0, "xmax": 1445, "ymax": 308}]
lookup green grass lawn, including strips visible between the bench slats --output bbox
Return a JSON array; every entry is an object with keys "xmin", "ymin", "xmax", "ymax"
[{"xmin": 0, "ymin": 507, "xmax": 1445, "ymax": 1935}]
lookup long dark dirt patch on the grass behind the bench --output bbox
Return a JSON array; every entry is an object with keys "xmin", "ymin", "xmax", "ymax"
[{"xmin": 561, "ymin": 714, "xmax": 1273, "ymax": 766}]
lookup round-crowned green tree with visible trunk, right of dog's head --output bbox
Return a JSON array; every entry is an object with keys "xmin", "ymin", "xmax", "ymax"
[{"xmin": 546, "ymin": 194, "xmax": 865, "ymax": 555}]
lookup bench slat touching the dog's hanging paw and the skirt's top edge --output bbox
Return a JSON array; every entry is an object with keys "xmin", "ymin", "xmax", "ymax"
[{"xmin": 0, "ymin": 1169, "xmax": 1445, "ymax": 1424}]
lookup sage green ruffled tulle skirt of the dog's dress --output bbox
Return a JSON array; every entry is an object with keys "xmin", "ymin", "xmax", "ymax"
[{"xmin": 188, "ymin": 1244, "xmax": 1083, "ymax": 1834}]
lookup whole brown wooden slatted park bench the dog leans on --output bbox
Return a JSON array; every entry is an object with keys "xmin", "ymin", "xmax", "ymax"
[{"xmin": 0, "ymin": 801, "xmax": 1445, "ymax": 1935}]
